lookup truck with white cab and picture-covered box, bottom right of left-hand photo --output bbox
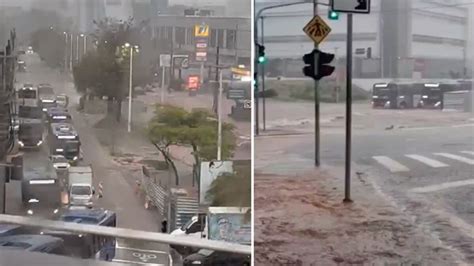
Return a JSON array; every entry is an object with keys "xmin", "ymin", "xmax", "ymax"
[{"xmin": 171, "ymin": 207, "xmax": 252, "ymax": 256}]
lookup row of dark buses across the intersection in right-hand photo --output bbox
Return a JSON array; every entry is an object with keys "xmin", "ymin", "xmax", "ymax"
[{"xmin": 371, "ymin": 80, "xmax": 472, "ymax": 109}]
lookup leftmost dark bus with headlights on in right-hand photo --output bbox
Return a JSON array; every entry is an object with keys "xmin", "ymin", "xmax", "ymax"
[{"xmin": 372, "ymin": 82, "xmax": 421, "ymax": 109}]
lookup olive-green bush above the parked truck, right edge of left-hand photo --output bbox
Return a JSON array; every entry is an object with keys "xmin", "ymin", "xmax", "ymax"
[{"xmin": 206, "ymin": 171, "xmax": 252, "ymax": 207}]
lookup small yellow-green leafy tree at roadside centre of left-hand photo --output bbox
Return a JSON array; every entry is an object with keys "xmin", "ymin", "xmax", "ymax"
[{"xmin": 148, "ymin": 105, "xmax": 235, "ymax": 185}]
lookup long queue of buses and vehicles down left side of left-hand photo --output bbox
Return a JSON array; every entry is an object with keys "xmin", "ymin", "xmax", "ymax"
[{"xmin": 0, "ymin": 81, "xmax": 131, "ymax": 260}]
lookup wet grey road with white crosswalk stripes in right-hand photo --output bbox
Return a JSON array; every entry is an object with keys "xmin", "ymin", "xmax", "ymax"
[{"xmin": 255, "ymin": 100, "xmax": 474, "ymax": 263}]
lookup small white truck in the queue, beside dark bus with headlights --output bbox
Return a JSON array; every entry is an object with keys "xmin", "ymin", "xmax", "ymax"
[{"xmin": 67, "ymin": 166, "xmax": 95, "ymax": 208}]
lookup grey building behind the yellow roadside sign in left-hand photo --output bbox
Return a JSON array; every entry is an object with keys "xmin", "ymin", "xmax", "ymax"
[{"xmin": 148, "ymin": 15, "xmax": 251, "ymax": 80}]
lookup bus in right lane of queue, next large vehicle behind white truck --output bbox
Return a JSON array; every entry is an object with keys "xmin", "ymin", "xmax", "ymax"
[{"xmin": 48, "ymin": 123, "xmax": 81, "ymax": 165}]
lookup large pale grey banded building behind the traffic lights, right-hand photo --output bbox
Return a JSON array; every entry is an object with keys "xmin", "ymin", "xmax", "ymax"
[{"xmin": 257, "ymin": 0, "xmax": 472, "ymax": 78}]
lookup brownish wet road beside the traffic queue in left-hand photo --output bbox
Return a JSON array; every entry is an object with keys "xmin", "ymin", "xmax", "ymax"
[{"xmin": 8, "ymin": 55, "xmax": 178, "ymax": 264}]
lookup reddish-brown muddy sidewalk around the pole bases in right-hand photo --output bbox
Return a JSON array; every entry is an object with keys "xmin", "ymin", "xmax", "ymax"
[{"xmin": 254, "ymin": 169, "xmax": 460, "ymax": 266}]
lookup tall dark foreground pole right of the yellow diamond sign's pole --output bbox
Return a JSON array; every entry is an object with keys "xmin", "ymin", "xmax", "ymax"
[{"xmin": 344, "ymin": 13, "xmax": 352, "ymax": 202}]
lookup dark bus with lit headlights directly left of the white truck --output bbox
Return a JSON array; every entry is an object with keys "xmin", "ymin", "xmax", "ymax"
[{"xmin": 21, "ymin": 167, "xmax": 62, "ymax": 219}]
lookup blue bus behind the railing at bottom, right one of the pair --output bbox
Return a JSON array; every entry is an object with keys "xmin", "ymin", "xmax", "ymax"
[{"xmin": 41, "ymin": 207, "xmax": 117, "ymax": 261}]
